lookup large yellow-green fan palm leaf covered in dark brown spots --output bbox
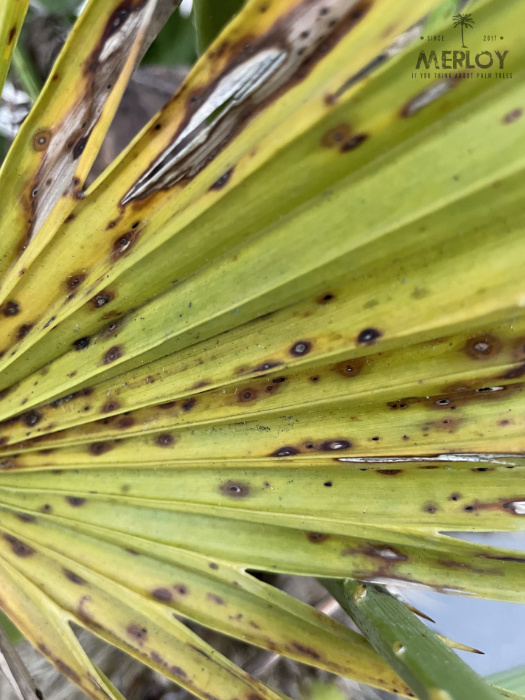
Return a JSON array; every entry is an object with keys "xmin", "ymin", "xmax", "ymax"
[{"xmin": 0, "ymin": 0, "xmax": 525, "ymax": 700}]
